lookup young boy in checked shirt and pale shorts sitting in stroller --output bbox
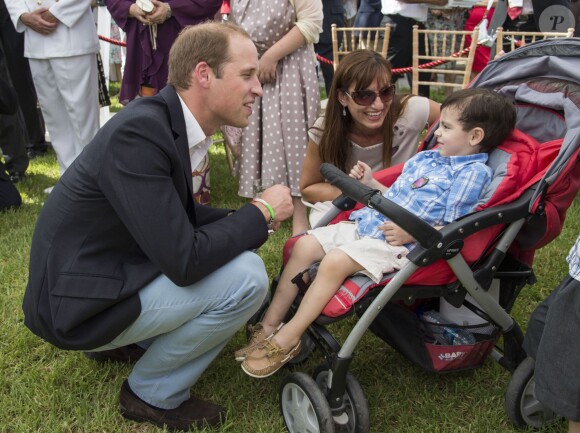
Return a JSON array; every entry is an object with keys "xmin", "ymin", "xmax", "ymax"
[{"xmin": 235, "ymin": 89, "xmax": 516, "ymax": 378}]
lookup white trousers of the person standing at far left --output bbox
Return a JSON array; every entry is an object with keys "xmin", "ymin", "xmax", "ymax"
[{"xmin": 28, "ymin": 53, "xmax": 99, "ymax": 175}]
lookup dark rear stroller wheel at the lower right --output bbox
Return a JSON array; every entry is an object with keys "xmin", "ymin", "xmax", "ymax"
[{"xmin": 505, "ymin": 357, "xmax": 559, "ymax": 428}]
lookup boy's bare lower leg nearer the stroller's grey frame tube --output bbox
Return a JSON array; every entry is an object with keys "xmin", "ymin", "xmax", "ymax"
[{"xmin": 272, "ymin": 249, "xmax": 363, "ymax": 349}]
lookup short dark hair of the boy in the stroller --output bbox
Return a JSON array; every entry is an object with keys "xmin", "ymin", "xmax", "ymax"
[{"xmin": 441, "ymin": 89, "xmax": 517, "ymax": 152}]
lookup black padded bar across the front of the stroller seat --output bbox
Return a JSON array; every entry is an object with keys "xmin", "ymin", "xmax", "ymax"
[{"xmin": 320, "ymin": 162, "xmax": 442, "ymax": 248}]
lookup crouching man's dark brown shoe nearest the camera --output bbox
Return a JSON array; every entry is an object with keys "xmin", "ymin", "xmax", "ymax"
[{"xmin": 119, "ymin": 381, "xmax": 225, "ymax": 431}]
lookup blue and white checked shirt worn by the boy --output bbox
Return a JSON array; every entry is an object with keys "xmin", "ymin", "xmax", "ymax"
[{"xmin": 350, "ymin": 150, "xmax": 492, "ymax": 247}]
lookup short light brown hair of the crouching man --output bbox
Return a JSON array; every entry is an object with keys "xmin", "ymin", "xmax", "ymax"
[{"xmin": 167, "ymin": 21, "xmax": 250, "ymax": 90}]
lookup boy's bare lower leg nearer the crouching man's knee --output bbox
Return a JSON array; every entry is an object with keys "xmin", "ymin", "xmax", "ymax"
[{"xmin": 262, "ymin": 235, "xmax": 324, "ymax": 335}]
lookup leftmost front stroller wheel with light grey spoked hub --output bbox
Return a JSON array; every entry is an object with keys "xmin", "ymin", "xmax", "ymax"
[{"xmin": 280, "ymin": 372, "xmax": 335, "ymax": 433}]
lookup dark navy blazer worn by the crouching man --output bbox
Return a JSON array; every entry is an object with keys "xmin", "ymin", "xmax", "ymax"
[{"xmin": 23, "ymin": 86, "xmax": 268, "ymax": 350}]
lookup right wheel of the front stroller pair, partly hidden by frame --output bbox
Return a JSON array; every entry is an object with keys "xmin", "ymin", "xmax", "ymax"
[{"xmin": 314, "ymin": 364, "xmax": 370, "ymax": 433}]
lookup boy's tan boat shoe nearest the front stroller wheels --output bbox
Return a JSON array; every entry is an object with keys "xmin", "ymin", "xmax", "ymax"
[{"xmin": 242, "ymin": 339, "xmax": 301, "ymax": 379}]
